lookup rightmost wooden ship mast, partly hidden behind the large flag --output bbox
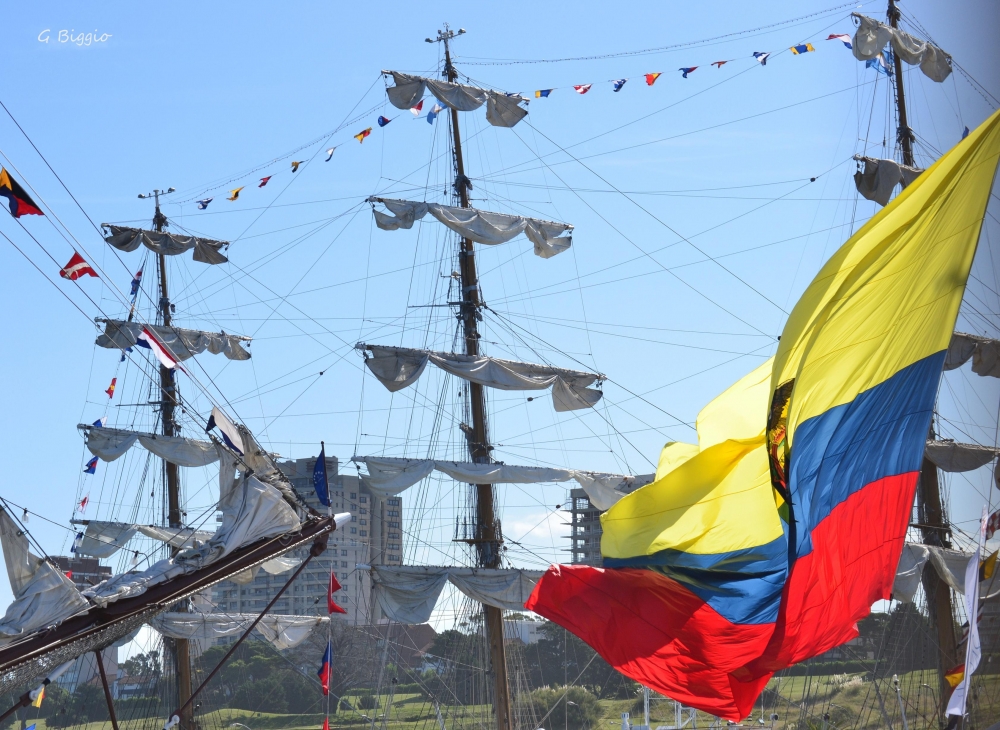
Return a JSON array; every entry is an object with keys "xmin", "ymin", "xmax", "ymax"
[{"xmin": 888, "ymin": 0, "xmax": 958, "ymax": 719}]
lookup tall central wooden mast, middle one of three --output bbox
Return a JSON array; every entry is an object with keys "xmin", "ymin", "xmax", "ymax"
[{"xmin": 427, "ymin": 23, "xmax": 513, "ymax": 730}]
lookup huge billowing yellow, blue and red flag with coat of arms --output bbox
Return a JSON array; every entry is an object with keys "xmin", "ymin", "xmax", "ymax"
[{"xmin": 525, "ymin": 112, "xmax": 1000, "ymax": 720}]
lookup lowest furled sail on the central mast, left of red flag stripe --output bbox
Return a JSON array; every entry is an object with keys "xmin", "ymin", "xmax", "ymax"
[{"xmin": 372, "ymin": 565, "xmax": 542, "ymax": 624}]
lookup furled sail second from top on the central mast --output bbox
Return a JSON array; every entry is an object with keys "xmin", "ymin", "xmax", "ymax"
[{"xmin": 368, "ymin": 197, "xmax": 573, "ymax": 259}]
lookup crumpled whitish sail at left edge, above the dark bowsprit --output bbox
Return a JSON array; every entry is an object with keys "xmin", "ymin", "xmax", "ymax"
[{"xmin": 0, "ymin": 508, "xmax": 90, "ymax": 644}]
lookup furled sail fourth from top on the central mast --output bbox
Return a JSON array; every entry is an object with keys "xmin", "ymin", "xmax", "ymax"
[{"xmin": 351, "ymin": 456, "xmax": 653, "ymax": 510}]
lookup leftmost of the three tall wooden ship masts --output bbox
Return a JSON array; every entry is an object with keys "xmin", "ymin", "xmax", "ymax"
[{"xmin": 139, "ymin": 188, "xmax": 194, "ymax": 730}]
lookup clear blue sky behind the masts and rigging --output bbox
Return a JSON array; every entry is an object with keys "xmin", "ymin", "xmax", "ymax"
[{"xmin": 0, "ymin": 0, "xmax": 1000, "ymax": 616}]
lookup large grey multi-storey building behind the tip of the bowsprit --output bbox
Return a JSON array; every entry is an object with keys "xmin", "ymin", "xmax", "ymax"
[{"xmin": 212, "ymin": 457, "xmax": 402, "ymax": 624}]
